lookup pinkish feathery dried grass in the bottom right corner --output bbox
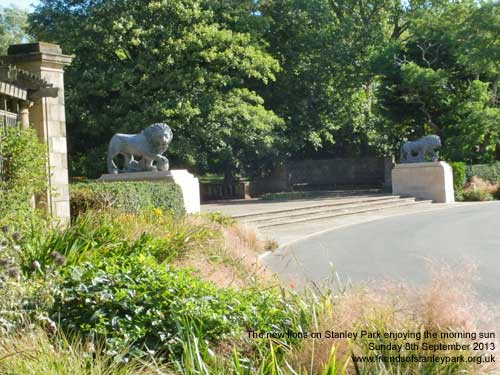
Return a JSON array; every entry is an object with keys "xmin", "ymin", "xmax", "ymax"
[{"xmin": 288, "ymin": 261, "xmax": 500, "ymax": 375}]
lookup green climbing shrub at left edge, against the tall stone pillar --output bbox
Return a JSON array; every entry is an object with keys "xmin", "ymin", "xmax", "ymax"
[{"xmin": 0, "ymin": 127, "xmax": 47, "ymax": 221}]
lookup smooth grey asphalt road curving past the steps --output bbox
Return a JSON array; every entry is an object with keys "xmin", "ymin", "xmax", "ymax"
[{"xmin": 262, "ymin": 202, "xmax": 500, "ymax": 304}]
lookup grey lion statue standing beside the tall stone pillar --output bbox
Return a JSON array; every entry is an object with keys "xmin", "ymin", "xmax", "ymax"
[{"xmin": 107, "ymin": 123, "xmax": 173, "ymax": 173}]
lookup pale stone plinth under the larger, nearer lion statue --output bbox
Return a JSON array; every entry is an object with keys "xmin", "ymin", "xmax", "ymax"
[{"xmin": 99, "ymin": 169, "xmax": 200, "ymax": 214}]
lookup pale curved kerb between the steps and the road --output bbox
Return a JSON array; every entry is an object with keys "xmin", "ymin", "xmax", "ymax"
[{"xmin": 258, "ymin": 201, "xmax": 495, "ymax": 262}]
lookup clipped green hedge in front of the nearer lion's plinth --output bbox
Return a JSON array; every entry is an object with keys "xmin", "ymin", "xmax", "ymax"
[{"xmin": 70, "ymin": 181, "xmax": 185, "ymax": 217}]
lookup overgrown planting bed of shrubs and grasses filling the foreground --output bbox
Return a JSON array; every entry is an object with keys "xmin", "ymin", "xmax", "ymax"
[{"xmin": 0, "ymin": 208, "xmax": 495, "ymax": 375}]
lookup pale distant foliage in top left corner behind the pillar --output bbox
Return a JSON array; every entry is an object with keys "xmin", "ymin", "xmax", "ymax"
[{"xmin": 0, "ymin": 6, "xmax": 31, "ymax": 55}]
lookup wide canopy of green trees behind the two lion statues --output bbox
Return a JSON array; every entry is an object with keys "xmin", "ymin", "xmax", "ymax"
[{"xmin": 30, "ymin": 0, "xmax": 500, "ymax": 176}]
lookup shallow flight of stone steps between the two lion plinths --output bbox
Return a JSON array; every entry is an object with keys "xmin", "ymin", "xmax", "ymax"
[{"xmin": 232, "ymin": 194, "xmax": 431, "ymax": 228}]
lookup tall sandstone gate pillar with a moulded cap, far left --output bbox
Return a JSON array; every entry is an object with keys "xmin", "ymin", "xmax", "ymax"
[{"xmin": 6, "ymin": 42, "xmax": 72, "ymax": 224}]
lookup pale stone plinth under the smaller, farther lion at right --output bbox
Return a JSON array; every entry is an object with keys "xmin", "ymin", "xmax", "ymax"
[{"xmin": 392, "ymin": 161, "xmax": 455, "ymax": 203}]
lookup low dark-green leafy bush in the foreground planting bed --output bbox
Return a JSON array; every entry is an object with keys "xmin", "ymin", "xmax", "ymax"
[{"xmin": 52, "ymin": 254, "xmax": 293, "ymax": 355}]
